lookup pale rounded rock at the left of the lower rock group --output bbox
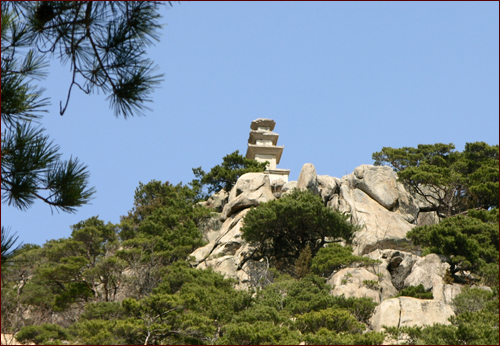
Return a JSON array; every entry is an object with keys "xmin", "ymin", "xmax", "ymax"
[{"xmin": 327, "ymin": 268, "xmax": 380, "ymax": 303}]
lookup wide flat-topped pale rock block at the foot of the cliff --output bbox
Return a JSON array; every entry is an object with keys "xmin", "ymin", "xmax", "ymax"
[{"xmin": 370, "ymin": 297, "xmax": 454, "ymax": 332}]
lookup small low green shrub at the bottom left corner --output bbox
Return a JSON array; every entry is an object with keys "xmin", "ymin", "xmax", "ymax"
[{"xmin": 16, "ymin": 323, "xmax": 69, "ymax": 345}]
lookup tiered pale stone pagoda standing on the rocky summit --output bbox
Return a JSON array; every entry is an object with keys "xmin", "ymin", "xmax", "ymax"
[{"xmin": 246, "ymin": 118, "xmax": 290, "ymax": 183}]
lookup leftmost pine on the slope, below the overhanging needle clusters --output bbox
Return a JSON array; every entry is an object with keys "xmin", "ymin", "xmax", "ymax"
[{"xmin": 7, "ymin": 217, "xmax": 125, "ymax": 311}]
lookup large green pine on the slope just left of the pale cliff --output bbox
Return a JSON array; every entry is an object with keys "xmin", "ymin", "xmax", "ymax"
[{"xmin": 117, "ymin": 180, "xmax": 212, "ymax": 298}]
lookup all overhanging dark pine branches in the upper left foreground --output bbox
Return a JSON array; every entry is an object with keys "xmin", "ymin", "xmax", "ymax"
[{"xmin": 1, "ymin": 1, "xmax": 168, "ymax": 212}]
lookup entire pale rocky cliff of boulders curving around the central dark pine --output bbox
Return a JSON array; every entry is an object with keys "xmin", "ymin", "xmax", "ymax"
[{"xmin": 191, "ymin": 163, "xmax": 460, "ymax": 331}]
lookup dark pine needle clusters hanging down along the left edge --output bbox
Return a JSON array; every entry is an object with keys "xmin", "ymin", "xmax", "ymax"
[{"xmin": 1, "ymin": 8, "xmax": 94, "ymax": 212}]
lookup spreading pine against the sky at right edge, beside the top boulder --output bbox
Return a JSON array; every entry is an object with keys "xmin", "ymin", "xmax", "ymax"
[{"xmin": 372, "ymin": 142, "xmax": 499, "ymax": 217}]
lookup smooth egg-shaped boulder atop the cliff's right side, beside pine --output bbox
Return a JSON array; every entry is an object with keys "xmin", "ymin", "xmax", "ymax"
[{"xmin": 353, "ymin": 165, "xmax": 399, "ymax": 210}]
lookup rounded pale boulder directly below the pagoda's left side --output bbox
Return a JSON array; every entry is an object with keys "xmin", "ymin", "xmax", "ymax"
[{"xmin": 221, "ymin": 173, "xmax": 276, "ymax": 220}]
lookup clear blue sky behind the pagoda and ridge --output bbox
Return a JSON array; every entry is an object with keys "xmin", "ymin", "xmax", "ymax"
[{"xmin": 2, "ymin": 1, "xmax": 499, "ymax": 244}]
